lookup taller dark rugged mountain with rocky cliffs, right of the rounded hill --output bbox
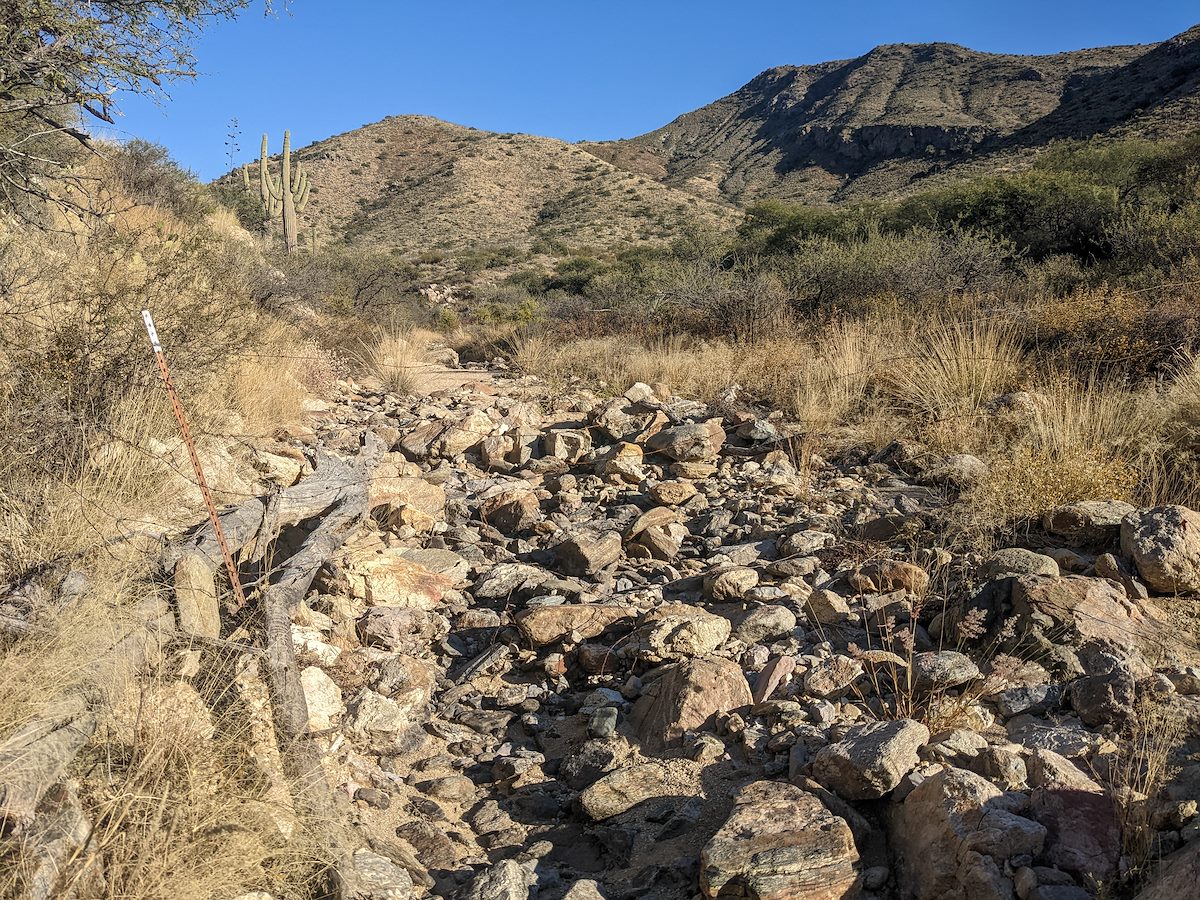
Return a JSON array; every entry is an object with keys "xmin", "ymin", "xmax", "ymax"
[{"xmin": 584, "ymin": 28, "xmax": 1200, "ymax": 203}]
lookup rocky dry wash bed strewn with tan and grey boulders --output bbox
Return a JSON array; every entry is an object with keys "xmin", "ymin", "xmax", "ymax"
[{"xmin": 117, "ymin": 350, "xmax": 1200, "ymax": 900}]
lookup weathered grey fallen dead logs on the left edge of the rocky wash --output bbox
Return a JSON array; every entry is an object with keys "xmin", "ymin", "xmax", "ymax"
[{"xmin": 0, "ymin": 436, "xmax": 382, "ymax": 897}]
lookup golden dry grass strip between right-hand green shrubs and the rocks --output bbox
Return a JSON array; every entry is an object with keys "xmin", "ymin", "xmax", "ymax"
[{"xmin": 511, "ymin": 307, "xmax": 1200, "ymax": 530}]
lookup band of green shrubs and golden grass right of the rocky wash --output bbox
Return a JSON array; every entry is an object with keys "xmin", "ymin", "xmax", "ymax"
[{"xmin": 477, "ymin": 132, "xmax": 1200, "ymax": 535}]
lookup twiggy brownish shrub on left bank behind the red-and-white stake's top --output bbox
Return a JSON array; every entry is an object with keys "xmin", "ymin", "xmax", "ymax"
[{"xmin": 0, "ymin": 228, "xmax": 254, "ymax": 466}]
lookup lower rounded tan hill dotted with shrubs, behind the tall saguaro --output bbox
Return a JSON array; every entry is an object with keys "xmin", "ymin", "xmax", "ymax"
[{"xmin": 227, "ymin": 115, "xmax": 739, "ymax": 251}]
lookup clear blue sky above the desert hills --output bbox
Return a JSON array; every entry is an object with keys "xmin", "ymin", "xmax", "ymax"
[{"xmin": 116, "ymin": 0, "xmax": 1200, "ymax": 179}]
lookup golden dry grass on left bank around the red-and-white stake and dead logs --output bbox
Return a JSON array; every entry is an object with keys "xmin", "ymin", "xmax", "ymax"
[{"xmin": 0, "ymin": 176, "xmax": 338, "ymax": 900}]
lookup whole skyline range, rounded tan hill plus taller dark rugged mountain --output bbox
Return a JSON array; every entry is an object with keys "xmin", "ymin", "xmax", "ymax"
[{"xmin": 227, "ymin": 26, "xmax": 1200, "ymax": 252}]
